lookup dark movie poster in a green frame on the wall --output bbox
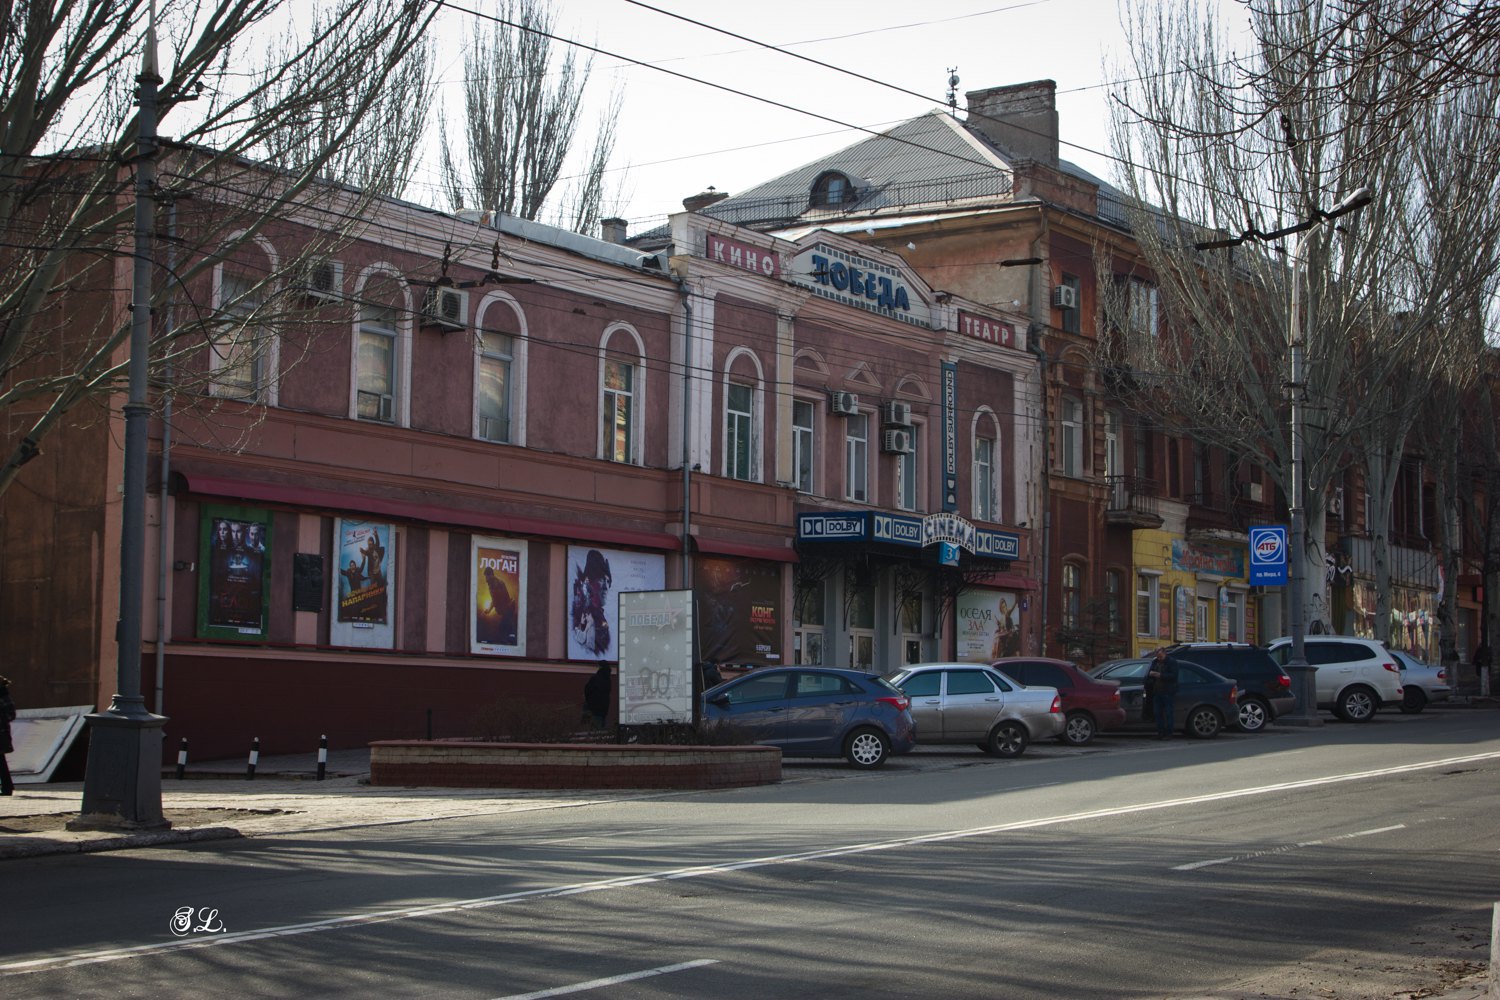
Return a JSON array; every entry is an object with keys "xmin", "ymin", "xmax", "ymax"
[{"xmin": 198, "ymin": 505, "xmax": 272, "ymax": 639}]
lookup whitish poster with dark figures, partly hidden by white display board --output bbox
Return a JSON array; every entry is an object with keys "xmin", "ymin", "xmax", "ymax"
[{"xmin": 567, "ymin": 546, "xmax": 666, "ymax": 660}]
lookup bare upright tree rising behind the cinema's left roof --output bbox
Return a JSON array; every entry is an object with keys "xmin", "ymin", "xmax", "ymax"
[{"xmin": 441, "ymin": 0, "xmax": 621, "ymax": 232}]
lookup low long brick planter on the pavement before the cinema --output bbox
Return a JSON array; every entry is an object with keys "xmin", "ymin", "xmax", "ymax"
[{"xmin": 371, "ymin": 739, "xmax": 782, "ymax": 789}]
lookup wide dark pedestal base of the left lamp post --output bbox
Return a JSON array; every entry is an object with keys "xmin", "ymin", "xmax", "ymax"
[{"xmin": 68, "ymin": 708, "xmax": 171, "ymax": 831}]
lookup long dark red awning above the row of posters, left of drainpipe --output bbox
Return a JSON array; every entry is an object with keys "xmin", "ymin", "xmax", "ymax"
[{"xmin": 177, "ymin": 472, "xmax": 687, "ymax": 558}]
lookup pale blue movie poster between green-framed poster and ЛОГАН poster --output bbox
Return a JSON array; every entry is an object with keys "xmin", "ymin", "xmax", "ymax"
[{"xmin": 329, "ymin": 519, "xmax": 396, "ymax": 649}]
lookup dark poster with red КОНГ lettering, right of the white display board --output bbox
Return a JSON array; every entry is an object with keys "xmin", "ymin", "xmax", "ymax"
[{"xmin": 693, "ymin": 556, "xmax": 782, "ymax": 666}]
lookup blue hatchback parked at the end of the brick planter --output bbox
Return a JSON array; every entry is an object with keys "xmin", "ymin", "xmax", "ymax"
[{"xmin": 704, "ymin": 667, "xmax": 915, "ymax": 768}]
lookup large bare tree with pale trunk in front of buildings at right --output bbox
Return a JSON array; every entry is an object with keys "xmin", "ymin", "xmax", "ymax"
[{"xmin": 1100, "ymin": 0, "xmax": 1496, "ymax": 628}]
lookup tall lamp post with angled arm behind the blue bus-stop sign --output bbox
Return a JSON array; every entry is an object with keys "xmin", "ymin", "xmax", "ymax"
[{"xmin": 1196, "ymin": 187, "xmax": 1371, "ymax": 726}]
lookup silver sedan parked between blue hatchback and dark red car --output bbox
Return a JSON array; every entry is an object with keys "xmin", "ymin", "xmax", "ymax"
[{"xmin": 890, "ymin": 663, "xmax": 1064, "ymax": 757}]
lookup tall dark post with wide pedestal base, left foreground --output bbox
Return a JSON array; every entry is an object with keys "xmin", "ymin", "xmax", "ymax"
[{"xmin": 68, "ymin": 22, "xmax": 171, "ymax": 831}]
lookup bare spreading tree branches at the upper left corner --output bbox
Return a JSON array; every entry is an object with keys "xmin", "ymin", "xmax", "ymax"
[{"xmin": 0, "ymin": 0, "xmax": 437, "ymax": 493}]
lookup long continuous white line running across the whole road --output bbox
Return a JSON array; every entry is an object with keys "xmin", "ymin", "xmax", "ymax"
[{"xmin": 0, "ymin": 751, "xmax": 1500, "ymax": 976}]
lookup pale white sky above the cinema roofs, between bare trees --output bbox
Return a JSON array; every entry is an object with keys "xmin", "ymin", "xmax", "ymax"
[{"xmin": 408, "ymin": 0, "xmax": 1242, "ymax": 232}]
